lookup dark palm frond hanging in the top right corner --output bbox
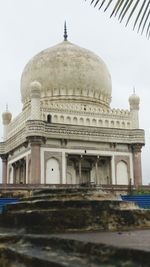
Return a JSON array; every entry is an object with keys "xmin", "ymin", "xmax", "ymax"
[{"xmin": 85, "ymin": 0, "xmax": 150, "ymax": 38}]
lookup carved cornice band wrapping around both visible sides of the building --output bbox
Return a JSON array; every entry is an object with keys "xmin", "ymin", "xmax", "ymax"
[{"xmin": 0, "ymin": 120, "xmax": 145, "ymax": 154}]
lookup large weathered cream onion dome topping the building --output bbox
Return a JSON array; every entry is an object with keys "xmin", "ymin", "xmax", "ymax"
[{"xmin": 21, "ymin": 41, "xmax": 111, "ymax": 108}]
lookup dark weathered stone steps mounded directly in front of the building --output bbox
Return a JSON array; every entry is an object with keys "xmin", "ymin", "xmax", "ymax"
[{"xmin": 0, "ymin": 188, "xmax": 150, "ymax": 234}]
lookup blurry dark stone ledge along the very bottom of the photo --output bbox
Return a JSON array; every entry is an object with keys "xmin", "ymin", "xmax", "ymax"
[{"xmin": 0, "ymin": 233, "xmax": 150, "ymax": 267}]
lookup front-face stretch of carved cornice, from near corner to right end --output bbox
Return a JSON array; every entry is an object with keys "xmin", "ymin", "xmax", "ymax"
[{"xmin": 26, "ymin": 121, "xmax": 145, "ymax": 145}]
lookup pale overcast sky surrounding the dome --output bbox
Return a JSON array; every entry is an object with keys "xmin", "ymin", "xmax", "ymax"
[{"xmin": 0, "ymin": 0, "xmax": 150, "ymax": 184}]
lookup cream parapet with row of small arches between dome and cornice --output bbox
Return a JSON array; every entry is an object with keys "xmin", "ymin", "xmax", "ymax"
[{"xmin": 41, "ymin": 103, "xmax": 132, "ymax": 129}]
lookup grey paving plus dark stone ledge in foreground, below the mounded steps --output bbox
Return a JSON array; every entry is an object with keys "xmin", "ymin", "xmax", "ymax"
[{"xmin": 0, "ymin": 229, "xmax": 150, "ymax": 267}]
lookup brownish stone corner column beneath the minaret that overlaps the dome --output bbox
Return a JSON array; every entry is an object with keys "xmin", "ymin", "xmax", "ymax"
[{"xmin": 28, "ymin": 136, "xmax": 44, "ymax": 184}]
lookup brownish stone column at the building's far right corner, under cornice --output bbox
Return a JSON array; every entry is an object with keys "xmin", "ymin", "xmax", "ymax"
[{"xmin": 132, "ymin": 144, "xmax": 142, "ymax": 186}]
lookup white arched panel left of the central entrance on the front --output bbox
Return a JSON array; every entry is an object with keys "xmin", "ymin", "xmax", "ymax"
[{"xmin": 46, "ymin": 158, "xmax": 60, "ymax": 184}]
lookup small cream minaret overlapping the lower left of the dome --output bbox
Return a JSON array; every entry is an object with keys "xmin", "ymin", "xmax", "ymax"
[{"xmin": 30, "ymin": 81, "xmax": 41, "ymax": 120}]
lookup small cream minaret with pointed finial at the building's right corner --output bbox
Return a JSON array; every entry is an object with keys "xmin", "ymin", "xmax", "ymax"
[{"xmin": 129, "ymin": 89, "xmax": 140, "ymax": 129}]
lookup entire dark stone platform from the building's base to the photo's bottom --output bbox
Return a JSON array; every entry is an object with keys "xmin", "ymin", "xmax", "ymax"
[{"xmin": 0, "ymin": 188, "xmax": 150, "ymax": 267}]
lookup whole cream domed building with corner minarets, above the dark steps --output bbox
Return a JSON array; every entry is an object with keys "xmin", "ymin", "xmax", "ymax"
[{"xmin": 0, "ymin": 28, "xmax": 144, "ymax": 186}]
